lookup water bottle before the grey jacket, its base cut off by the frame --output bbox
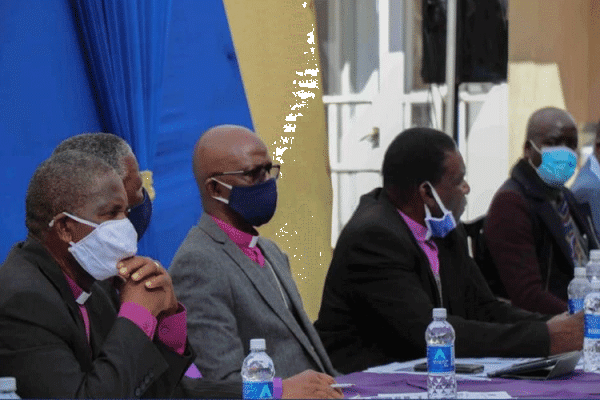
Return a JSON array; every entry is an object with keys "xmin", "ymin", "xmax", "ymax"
[{"xmin": 242, "ymin": 339, "xmax": 275, "ymax": 399}]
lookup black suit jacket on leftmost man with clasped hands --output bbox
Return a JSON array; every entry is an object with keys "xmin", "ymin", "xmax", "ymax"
[{"xmin": 0, "ymin": 238, "xmax": 194, "ymax": 398}]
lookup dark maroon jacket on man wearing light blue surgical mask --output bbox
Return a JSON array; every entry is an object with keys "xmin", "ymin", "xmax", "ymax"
[{"xmin": 484, "ymin": 159, "xmax": 596, "ymax": 314}]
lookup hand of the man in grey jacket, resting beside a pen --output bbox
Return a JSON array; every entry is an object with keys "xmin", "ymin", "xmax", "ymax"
[{"xmin": 282, "ymin": 369, "xmax": 344, "ymax": 399}]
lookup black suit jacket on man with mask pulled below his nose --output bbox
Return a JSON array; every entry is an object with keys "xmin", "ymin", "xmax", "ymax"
[{"xmin": 315, "ymin": 189, "xmax": 550, "ymax": 373}]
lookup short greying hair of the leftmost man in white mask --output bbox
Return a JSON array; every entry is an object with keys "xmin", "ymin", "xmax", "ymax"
[{"xmin": 25, "ymin": 150, "xmax": 116, "ymax": 240}]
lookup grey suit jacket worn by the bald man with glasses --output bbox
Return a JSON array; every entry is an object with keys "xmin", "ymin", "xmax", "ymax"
[{"xmin": 169, "ymin": 214, "xmax": 336, "ymax": 380}]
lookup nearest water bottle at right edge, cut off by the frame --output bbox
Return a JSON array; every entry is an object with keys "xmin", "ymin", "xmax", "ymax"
[{"xmin": 583, "ymin": 277, "xmax": 600, "ymax": 372}]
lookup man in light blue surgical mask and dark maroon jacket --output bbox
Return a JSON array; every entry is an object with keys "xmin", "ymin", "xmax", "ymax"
[{"xmin": 484, "ymin": 107, "xmax": 597, "ymax": 314}]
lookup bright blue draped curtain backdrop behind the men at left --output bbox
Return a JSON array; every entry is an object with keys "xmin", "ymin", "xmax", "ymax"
[{"xmin": 0, "ymin": 0, "xmax": 252, "ymax": 265}]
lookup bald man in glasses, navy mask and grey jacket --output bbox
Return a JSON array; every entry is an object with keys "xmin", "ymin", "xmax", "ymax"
[{"xmin": 169, "ymin": 125, "xmax": 341, "ymax": 398}]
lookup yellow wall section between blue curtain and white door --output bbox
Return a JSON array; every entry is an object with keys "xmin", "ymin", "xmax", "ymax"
[{"xmin": 224, "ymin": 0, "xmax": 332, "ymax": 320}]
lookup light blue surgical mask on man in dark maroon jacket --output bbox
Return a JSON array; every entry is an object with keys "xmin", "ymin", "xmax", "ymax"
[{"xmin": 529, "ymin": 140, "xmax": 577, "ymax": 187}]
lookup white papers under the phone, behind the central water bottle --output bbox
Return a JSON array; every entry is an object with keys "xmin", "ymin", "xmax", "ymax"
[{"xmin": 365, "ymin": 357, "xmax": 536, "ymax": 380}]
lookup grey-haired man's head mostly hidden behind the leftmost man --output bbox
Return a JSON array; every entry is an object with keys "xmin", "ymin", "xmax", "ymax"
[{"xmin": 53, "ymin": 132, "xmax": 152, "ymax": 240}]
